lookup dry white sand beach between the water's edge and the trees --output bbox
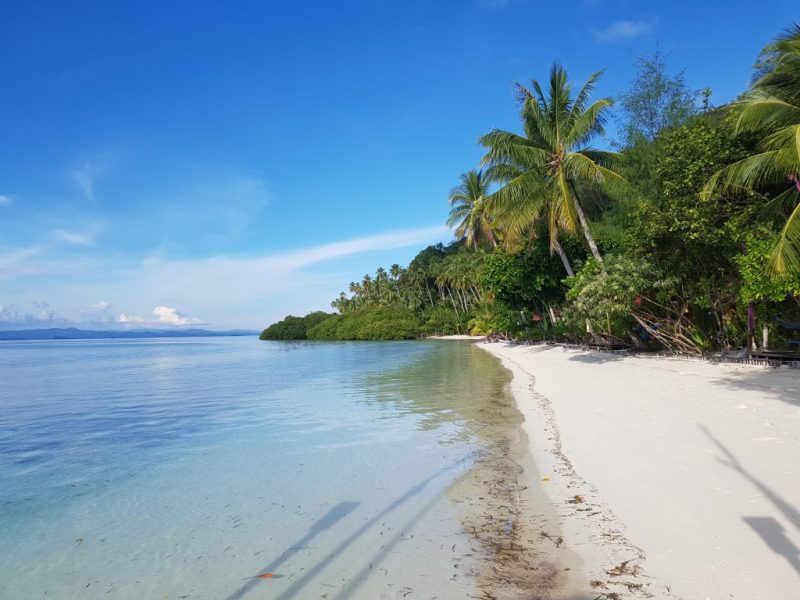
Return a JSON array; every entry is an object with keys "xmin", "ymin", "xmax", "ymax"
[{"xmin": 481, "ymin": 343, "xmax": 800, "ymax": 600}]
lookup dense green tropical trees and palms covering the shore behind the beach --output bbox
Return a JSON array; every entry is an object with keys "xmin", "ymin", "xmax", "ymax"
[{"xmin": 262, "ymin": 25, "xmax": 800, "ymax": 353}]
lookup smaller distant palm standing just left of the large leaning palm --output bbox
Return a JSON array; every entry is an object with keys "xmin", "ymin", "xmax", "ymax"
[{"xmin": 447, "ymin": 169, "xmax": 497, "ymax": 249}]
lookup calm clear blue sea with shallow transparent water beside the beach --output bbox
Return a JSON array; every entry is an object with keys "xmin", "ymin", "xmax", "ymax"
[{"xmin": 0, "ymin": 338, "xmax": 513, "ymax": 600}]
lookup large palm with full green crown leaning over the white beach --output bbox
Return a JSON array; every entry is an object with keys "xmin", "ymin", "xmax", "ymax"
[{"xmin": 479, "ymin": 64, "xmax": 625, "ymax": 273}]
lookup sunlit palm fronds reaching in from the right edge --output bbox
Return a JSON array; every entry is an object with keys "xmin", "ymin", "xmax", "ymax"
[{"xmin": 703, "ymin": 24, "xmax": 800, "ymax": 273}]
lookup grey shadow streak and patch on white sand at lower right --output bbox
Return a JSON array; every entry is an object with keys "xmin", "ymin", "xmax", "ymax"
[{"xmin": 699, "ymin": 425, "xmax": 800, "ymax": 575}]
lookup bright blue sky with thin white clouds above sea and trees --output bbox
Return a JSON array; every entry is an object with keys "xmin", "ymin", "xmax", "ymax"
[{"xmin": 0, "ymin": 0, "xmax": 800, "ymax": 329}]
